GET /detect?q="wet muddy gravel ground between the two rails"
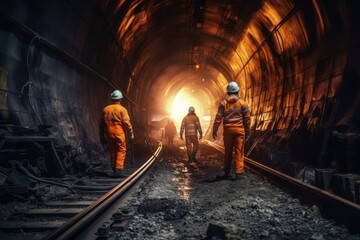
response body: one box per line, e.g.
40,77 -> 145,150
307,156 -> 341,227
113,145 -> 360,240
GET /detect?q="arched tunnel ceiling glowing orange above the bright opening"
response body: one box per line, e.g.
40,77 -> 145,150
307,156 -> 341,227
103,1 -> 260,115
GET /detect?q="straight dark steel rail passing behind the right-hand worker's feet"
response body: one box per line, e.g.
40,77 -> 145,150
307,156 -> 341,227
204,140 -> 360,233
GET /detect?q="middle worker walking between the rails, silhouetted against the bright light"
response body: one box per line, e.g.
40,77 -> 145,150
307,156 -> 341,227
180,107 -> 202,162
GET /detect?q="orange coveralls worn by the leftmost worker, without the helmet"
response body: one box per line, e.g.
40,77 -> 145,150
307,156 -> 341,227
103,102 -> 133,170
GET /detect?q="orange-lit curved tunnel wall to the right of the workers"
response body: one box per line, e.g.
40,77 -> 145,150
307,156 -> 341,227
239,1 -> 360,175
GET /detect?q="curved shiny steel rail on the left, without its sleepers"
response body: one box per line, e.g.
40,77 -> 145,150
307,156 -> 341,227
44,141 -> 162,240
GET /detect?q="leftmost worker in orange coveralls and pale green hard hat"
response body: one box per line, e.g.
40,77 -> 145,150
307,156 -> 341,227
100,90 -> 134,177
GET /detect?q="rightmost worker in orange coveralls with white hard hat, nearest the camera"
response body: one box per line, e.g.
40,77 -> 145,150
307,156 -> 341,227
212,82 -> 250,179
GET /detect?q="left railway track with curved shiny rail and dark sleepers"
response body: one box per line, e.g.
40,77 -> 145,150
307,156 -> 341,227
0,142 -> 162,239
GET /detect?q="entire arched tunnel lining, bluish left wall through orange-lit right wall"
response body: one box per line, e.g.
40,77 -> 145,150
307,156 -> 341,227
0,0 -> 360,178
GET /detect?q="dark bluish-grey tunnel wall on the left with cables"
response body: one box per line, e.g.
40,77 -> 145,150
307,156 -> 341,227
0,0 -> 127,150
